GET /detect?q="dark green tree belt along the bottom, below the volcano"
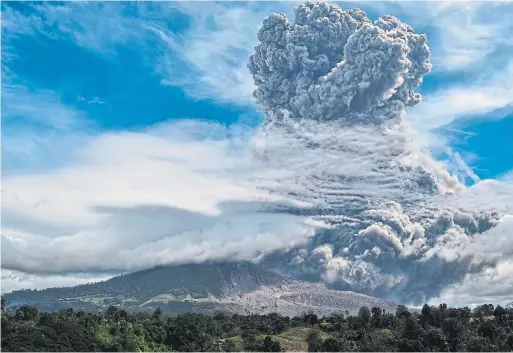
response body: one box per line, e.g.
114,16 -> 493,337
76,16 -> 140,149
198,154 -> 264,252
2,300 -> 513,352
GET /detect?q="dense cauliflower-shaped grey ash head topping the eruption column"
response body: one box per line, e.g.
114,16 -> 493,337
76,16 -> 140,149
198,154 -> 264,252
249,2 -> 431,120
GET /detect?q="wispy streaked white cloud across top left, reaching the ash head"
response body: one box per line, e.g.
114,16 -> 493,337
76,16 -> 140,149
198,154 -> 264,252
2,2 -> 286,104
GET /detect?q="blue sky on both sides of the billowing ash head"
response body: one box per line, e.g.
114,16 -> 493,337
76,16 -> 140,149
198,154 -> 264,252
2,3 -> 513,178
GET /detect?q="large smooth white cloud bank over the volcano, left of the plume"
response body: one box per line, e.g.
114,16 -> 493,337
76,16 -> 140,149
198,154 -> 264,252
2,121 -> 318,280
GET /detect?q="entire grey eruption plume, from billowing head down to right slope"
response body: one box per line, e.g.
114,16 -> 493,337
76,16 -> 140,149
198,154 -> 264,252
248,2 -> 513,304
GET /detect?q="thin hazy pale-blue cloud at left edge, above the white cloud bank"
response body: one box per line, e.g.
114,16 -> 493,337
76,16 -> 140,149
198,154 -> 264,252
2,84 -> 94,177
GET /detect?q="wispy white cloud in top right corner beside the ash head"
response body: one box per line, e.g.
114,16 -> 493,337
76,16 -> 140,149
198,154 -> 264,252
370,0 -> 513,73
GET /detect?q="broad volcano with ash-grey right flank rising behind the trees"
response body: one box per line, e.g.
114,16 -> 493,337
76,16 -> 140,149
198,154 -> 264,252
4,262 -> 397,316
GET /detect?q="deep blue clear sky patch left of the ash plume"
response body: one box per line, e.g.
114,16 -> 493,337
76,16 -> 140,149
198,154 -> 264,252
4,3 -> 256,131
